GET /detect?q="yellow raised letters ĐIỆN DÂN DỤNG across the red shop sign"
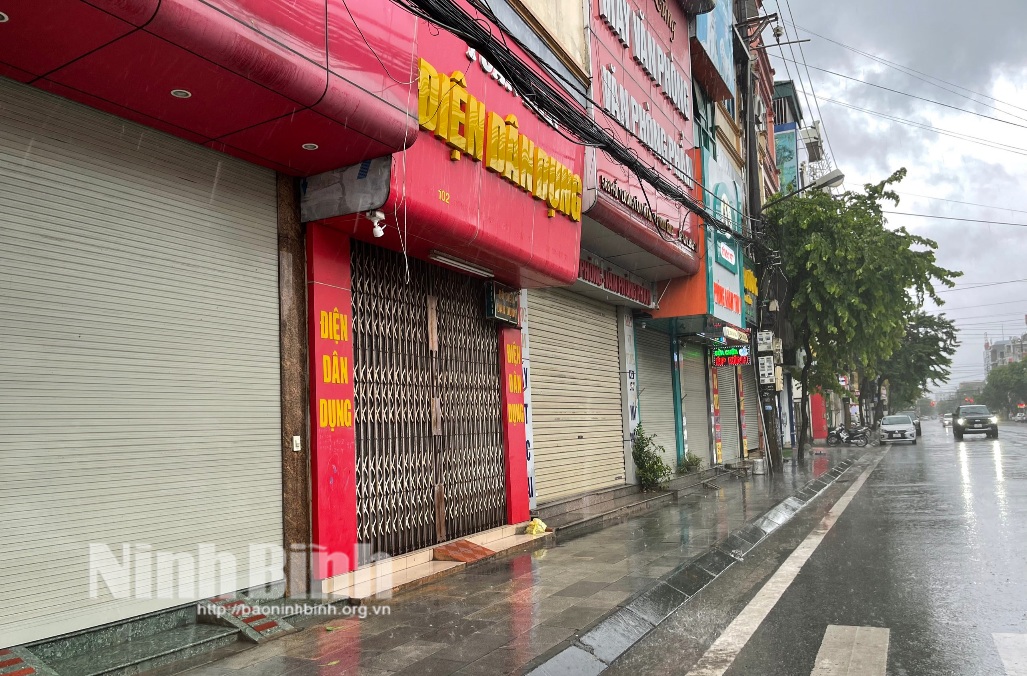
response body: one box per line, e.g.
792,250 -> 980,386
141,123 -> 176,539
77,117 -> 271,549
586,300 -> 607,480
418,59 -> 581,221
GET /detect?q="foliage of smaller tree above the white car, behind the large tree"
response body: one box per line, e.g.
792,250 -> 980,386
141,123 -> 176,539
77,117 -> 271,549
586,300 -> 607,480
877,310 -> 959,413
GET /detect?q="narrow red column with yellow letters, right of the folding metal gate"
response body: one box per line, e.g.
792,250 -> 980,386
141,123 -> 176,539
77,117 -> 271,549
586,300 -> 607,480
499,328 -> 530,524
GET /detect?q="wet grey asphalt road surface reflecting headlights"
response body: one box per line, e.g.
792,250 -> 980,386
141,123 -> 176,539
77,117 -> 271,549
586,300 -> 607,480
611,420 -> 1027,676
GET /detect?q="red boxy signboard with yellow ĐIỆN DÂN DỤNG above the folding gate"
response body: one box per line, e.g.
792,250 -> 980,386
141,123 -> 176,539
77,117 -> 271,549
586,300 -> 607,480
302,7 -> 585,286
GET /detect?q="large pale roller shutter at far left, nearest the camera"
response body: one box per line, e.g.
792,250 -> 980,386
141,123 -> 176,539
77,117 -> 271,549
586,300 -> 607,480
0,78 -> 282,645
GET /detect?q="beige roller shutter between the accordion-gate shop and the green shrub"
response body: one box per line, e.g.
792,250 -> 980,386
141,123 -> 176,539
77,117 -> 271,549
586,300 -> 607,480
528,289 -> 624,501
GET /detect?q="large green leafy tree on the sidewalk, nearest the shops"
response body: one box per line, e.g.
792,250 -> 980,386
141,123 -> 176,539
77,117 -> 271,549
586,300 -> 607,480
766,170 -> 961,458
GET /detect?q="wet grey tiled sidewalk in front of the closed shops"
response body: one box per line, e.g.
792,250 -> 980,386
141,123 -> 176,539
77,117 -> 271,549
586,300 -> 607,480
170,451 -> 844,676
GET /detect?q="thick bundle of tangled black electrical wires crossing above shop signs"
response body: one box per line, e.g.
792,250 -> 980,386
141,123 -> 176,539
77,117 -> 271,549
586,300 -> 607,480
392,0 -> 759,246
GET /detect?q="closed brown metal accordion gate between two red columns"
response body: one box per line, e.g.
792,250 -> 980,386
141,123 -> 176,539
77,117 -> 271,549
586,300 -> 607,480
351,239 -> 506,565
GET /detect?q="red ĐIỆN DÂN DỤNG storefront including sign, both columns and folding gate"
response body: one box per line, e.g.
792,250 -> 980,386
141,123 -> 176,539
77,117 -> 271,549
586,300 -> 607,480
303,2 -> 584,579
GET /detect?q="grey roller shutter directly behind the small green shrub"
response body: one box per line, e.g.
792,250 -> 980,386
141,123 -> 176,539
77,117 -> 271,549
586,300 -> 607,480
635,328 -> 678,467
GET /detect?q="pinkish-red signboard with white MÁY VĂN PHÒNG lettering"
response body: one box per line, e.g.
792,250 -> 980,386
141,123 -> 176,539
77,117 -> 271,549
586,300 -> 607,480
586,0 -> 699,262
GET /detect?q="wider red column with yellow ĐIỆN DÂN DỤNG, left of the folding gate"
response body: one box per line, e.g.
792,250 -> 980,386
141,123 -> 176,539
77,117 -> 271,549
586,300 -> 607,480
307,224 -> 356,579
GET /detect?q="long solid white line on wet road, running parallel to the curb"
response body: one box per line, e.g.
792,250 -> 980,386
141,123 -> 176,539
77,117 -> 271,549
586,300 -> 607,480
688,448 -> 888,676
